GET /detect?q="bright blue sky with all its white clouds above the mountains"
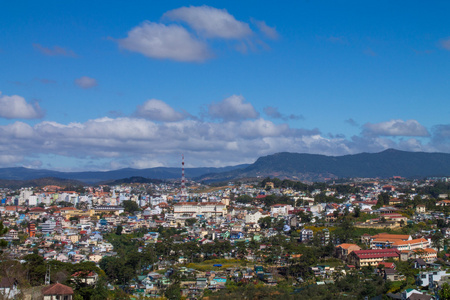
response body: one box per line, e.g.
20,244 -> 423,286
0,1 -> 450,170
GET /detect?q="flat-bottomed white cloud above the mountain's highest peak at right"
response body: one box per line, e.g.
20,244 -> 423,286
363,120 -> 429,136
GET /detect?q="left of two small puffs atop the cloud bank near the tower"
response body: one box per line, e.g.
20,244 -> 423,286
135,99 -> 185,122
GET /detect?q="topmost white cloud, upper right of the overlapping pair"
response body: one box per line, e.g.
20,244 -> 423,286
164,5 -> 252,39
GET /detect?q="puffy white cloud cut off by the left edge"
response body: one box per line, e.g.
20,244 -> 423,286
0,92 -> 44,119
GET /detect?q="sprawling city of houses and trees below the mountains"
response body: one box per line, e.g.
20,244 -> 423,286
0,178 -> 450,299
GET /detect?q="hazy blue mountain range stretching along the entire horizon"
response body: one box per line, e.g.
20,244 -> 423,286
0,149 -> 450,184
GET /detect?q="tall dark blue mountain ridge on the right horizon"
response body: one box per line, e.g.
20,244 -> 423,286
199,149 -> 450,181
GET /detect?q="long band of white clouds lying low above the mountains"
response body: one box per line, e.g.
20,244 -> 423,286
0,95 -> 450,170
